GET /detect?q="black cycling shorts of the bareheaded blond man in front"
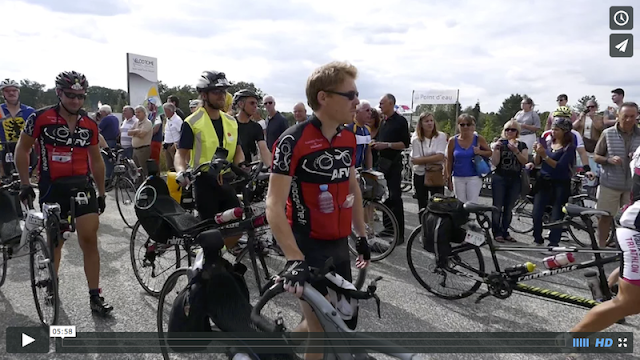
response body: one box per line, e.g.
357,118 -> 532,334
294,234 -> 353,296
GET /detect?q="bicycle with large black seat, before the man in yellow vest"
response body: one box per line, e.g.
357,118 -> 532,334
129,157 -> 285,296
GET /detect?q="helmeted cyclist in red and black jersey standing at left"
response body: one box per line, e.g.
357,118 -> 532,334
15,71 -> 113,315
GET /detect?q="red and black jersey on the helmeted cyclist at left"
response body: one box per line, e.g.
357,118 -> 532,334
23,105 -> 98,185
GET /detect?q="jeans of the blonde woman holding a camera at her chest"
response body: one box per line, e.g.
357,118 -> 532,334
491,174 -> 521,238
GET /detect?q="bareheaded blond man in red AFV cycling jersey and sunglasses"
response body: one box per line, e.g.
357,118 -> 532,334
267,62 -> 371,359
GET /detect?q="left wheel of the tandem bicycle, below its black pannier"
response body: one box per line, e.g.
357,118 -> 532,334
407,226 -> 484,300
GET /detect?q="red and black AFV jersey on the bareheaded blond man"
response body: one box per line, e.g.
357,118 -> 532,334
271,116 -> 356,240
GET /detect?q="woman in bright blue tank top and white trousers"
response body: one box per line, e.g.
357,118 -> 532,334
446,114 -> 492,203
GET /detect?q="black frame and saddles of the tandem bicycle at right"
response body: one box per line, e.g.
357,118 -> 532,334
448,213 -> 621,309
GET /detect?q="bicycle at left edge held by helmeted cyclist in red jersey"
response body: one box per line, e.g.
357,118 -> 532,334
0,176 -> 87,327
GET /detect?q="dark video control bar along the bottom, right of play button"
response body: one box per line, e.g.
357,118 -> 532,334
56,332 -> 633,354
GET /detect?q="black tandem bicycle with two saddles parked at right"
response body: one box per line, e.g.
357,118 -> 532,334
407,203 -> 620,309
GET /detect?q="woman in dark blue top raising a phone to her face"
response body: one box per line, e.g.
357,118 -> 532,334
533,118 -> 576,246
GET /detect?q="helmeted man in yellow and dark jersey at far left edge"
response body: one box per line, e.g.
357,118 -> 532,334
0,79 -> 37,178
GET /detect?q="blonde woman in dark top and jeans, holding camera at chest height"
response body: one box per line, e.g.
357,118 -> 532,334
491,120 -> 529,242
